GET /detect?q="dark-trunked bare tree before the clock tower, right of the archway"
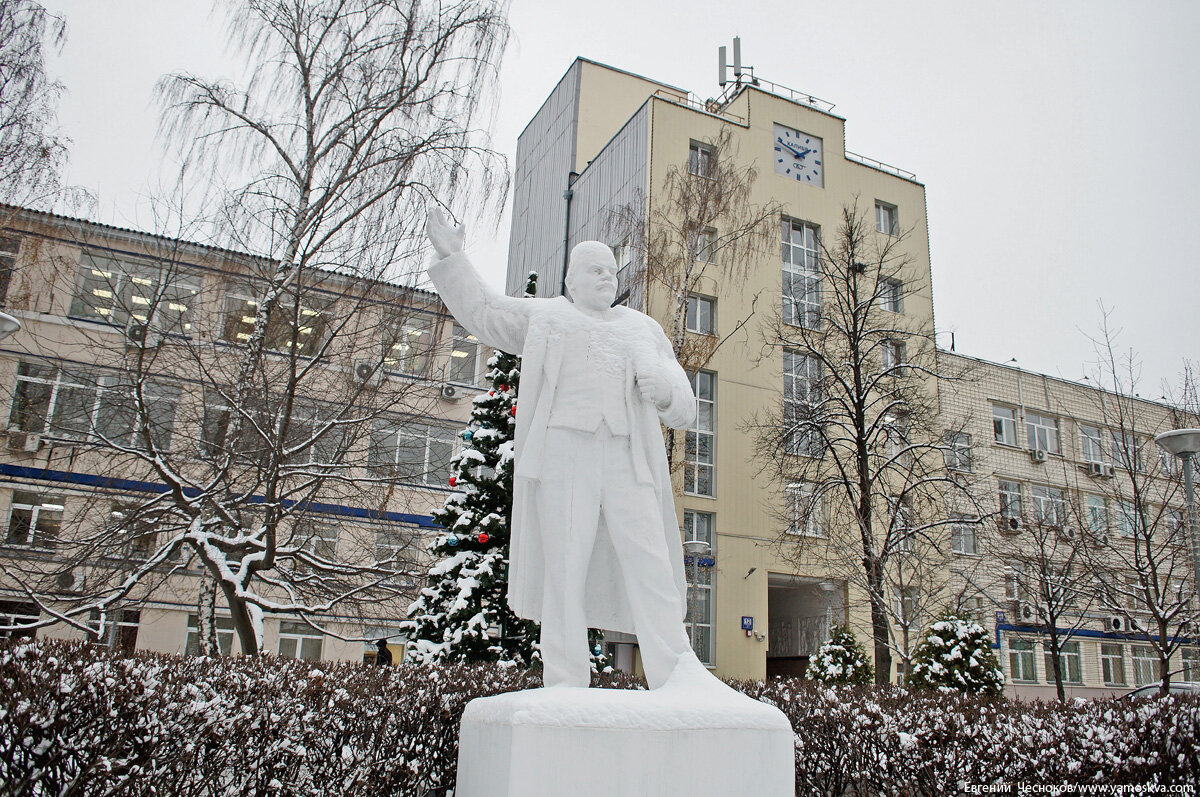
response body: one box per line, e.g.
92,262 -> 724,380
748,204 -> 972,683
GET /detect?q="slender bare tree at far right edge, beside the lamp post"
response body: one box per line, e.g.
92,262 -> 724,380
1086,311 -> 1200,695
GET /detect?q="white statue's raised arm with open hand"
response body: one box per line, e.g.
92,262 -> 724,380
425,210 -> 532,353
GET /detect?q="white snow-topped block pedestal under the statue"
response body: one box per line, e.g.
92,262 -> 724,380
455,678 -> 796,797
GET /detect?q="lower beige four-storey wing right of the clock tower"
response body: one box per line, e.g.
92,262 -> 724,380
940,352 -> 1200,697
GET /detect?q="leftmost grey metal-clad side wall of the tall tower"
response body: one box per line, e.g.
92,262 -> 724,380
505,61 -> 581,296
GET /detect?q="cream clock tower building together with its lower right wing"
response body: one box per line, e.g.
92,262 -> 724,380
508,59 -> 1196,695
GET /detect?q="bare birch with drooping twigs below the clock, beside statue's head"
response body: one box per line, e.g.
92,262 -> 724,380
610,127 -> 782,467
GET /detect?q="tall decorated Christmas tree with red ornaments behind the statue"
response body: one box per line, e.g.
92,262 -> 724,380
401,274 -> 539,666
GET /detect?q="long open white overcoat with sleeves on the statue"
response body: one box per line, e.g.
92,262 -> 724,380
428,246 -> 696,634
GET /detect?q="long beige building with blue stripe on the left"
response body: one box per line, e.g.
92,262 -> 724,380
0,206 -> 486,659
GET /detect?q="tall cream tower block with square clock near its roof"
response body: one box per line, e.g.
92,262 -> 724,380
508,59 -> 932,678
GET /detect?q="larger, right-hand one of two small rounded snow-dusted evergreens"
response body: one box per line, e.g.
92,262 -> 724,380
908,612 -> 1004,695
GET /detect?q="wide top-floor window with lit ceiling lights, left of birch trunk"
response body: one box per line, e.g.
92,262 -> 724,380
68,252 -> 200,334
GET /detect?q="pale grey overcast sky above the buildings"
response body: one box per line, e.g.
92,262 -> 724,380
46,0 -> 1200,397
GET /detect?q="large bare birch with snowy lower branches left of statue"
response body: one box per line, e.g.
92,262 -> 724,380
0,0 -> 506,653
